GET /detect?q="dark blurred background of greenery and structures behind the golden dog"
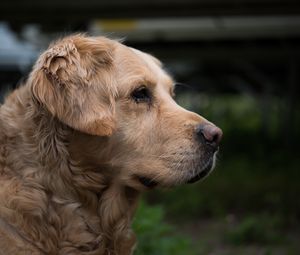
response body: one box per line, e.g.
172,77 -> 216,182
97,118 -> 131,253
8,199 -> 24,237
0,0 -> 300,255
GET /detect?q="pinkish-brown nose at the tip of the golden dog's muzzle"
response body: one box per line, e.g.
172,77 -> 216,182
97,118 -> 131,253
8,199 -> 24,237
196,124 -> 223,149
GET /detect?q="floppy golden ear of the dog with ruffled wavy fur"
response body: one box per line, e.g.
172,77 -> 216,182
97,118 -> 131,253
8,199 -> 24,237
30,35 -> 116,136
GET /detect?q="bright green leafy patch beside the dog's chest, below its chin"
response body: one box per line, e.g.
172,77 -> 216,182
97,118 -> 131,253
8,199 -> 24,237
133,202 -> 195,255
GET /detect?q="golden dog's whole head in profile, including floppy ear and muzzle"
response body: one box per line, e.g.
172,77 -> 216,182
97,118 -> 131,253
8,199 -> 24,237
30,35 -> 222,189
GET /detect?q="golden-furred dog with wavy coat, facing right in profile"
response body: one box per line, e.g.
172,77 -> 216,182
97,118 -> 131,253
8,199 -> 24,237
0,34 -> 222,255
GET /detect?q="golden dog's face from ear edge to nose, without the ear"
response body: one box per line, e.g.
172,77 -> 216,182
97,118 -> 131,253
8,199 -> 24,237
111,45 -> 221,187
